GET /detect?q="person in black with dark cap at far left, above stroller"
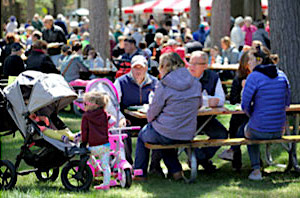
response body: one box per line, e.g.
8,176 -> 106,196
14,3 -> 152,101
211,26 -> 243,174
3,43 -> 25,78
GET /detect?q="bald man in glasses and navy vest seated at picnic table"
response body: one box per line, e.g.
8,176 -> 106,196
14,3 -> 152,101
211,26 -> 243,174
188,51 -> 228,172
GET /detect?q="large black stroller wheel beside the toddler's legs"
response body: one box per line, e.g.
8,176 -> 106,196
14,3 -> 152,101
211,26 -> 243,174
61,160 -> 93,191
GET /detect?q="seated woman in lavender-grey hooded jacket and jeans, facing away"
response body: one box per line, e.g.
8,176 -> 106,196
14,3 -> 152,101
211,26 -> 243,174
134,52 -> 201,180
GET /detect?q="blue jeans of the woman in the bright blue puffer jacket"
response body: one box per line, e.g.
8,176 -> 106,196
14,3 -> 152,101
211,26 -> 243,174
237,123 -> 282,169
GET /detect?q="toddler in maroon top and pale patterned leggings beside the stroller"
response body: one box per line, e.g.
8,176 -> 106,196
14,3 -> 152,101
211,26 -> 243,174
81,91 -> 110,190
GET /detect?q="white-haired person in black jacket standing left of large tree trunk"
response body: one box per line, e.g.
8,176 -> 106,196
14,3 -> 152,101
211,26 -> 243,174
42,15 -> 67,65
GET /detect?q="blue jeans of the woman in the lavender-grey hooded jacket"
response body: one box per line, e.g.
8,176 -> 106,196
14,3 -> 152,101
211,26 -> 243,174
134,123 -> 187,177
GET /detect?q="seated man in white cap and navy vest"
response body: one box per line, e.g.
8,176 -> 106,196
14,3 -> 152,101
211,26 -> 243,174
114,55 -> 158,164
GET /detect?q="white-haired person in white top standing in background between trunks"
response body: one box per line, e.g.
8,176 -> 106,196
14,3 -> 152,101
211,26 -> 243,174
230,16 -> 245,51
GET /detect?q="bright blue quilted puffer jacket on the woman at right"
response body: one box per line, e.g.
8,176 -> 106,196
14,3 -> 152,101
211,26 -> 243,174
242,65 -> 289,132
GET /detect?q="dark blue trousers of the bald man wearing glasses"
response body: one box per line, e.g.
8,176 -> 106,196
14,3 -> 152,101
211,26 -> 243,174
195,117 -> 228,161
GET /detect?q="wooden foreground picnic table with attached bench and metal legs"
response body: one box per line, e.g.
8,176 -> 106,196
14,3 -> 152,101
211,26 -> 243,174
125,104 -> 300,183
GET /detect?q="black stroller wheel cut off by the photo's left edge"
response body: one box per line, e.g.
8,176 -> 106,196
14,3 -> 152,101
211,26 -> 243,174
0,160 -> 17,190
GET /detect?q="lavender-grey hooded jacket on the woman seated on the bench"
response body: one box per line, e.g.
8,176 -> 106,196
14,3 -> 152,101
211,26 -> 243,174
147,68 -> 202,140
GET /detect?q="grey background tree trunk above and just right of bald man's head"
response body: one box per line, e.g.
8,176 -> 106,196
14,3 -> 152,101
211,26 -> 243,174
210,0 -> 230,47
